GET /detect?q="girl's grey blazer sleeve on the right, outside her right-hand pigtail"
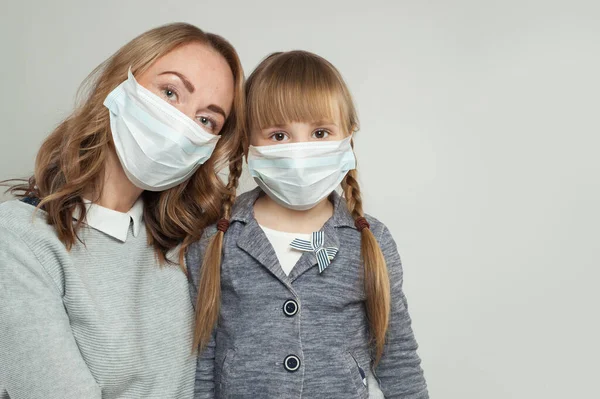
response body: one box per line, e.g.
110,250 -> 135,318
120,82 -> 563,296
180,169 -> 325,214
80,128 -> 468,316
375,227 -> 429,399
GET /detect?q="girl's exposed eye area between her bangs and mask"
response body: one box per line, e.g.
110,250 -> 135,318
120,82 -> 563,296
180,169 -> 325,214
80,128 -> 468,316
250,118 -> 347,147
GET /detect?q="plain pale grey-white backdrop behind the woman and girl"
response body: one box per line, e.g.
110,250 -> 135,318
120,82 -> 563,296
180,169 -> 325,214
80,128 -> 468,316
0,0 -> 600,399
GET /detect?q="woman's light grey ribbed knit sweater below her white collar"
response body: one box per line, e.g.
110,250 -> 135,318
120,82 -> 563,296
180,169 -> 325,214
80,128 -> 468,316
0,201 -> 196,399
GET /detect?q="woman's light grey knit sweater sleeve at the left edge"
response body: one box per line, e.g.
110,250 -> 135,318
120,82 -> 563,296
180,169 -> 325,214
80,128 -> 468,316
0,223 -> 101,399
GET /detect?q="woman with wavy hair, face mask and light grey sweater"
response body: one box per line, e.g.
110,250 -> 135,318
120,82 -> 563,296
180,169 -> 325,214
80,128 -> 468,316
0,24 -> 244,399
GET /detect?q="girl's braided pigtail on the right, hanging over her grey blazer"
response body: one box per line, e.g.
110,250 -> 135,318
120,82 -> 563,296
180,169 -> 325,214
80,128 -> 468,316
342,170 -> 391,364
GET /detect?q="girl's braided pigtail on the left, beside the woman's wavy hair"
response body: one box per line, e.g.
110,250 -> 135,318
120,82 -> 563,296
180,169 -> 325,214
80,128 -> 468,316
194,152 -> 243,351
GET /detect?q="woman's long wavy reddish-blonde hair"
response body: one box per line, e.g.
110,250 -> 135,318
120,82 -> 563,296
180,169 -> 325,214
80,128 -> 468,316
5,23 -> 246,265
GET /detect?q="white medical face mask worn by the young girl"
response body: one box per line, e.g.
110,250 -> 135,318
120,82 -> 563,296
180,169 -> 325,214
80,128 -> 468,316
248,136 -> 356,211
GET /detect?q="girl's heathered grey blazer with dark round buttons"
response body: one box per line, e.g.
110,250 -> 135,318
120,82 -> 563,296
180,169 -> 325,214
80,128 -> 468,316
186,188 -> 428,399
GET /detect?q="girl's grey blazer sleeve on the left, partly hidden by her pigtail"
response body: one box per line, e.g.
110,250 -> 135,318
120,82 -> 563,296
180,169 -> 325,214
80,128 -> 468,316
185,238 -> 216,399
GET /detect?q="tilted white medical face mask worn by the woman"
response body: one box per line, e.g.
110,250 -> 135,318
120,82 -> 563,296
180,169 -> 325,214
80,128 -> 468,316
104,70 -> 219,191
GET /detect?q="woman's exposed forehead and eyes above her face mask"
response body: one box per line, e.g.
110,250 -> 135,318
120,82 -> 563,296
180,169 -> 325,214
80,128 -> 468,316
135,43 -> 234,134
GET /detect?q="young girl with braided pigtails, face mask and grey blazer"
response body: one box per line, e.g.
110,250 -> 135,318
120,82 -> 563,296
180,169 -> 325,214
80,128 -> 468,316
186,51 -> 428,399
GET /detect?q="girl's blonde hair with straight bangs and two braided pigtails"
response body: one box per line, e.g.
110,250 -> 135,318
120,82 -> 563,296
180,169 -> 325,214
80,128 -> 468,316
194,51 -> 390,362
